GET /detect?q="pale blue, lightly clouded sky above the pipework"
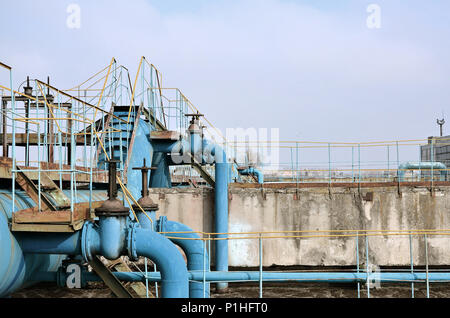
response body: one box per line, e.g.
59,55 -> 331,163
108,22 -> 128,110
0,0 -> 450,169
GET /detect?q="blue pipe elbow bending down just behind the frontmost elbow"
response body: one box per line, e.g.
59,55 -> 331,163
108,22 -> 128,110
158,216 -> 209,298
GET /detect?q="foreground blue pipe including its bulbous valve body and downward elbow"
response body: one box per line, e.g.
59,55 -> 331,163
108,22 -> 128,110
10,217 -> 189,298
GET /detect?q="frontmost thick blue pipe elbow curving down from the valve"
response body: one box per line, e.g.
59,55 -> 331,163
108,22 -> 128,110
130,227 -> 189,298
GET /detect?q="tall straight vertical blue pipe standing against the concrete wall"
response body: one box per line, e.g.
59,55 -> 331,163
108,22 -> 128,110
214,160 -> 228,291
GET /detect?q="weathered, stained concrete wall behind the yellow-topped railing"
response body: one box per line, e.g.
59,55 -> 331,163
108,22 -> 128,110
151,187 -> 450,266
